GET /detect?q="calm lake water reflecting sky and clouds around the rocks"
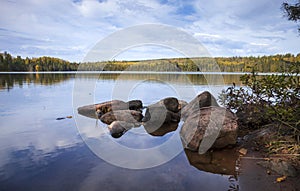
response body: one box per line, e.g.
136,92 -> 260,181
0,74 -> 239,190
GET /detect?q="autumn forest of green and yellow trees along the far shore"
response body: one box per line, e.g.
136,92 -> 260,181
0,52 -> 300,72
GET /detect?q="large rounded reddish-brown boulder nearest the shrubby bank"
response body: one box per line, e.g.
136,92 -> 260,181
180,106 -> 238,153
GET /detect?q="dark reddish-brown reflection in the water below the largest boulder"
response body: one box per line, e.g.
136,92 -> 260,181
184,149 -> 238,176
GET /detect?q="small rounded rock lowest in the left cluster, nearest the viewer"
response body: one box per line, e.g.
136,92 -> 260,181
108,121 -> 135,138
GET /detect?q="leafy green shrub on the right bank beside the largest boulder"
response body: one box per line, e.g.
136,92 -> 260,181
219,62 -> 300,135
